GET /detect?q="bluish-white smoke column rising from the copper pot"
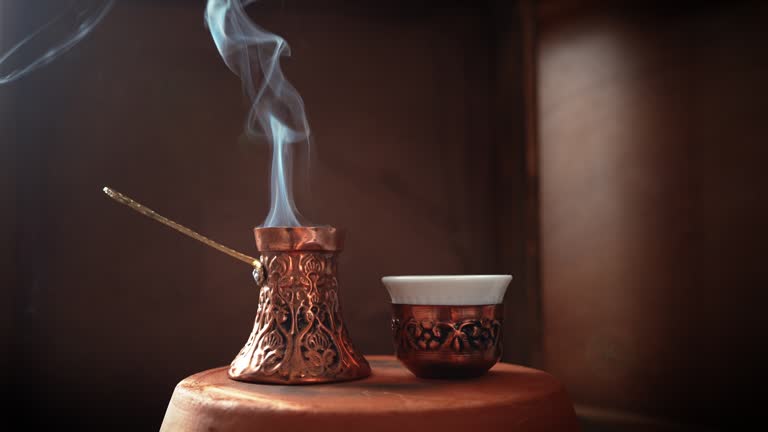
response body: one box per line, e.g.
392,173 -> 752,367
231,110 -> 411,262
205,0 -> 309,227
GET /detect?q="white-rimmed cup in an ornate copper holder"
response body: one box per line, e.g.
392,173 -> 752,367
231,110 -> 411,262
381,275 -> 512,378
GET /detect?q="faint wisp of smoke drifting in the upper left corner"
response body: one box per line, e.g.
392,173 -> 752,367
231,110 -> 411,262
0,0 -> 114,85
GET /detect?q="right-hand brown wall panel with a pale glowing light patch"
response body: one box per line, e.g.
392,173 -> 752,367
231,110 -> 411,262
537,2 -> 768,430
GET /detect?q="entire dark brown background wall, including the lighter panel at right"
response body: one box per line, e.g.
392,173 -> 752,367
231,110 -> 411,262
6,0 -> 768,430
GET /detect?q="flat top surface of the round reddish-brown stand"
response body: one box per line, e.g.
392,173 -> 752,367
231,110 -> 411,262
176,356 -> 564,414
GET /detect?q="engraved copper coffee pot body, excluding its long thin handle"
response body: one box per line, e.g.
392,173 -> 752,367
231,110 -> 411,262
229,226 -> 371,384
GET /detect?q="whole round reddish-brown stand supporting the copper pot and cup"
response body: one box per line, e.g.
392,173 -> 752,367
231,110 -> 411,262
160,356 -> 579,432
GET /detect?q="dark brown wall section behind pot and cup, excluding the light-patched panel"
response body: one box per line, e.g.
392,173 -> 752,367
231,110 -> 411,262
0,0 -> 528,430
